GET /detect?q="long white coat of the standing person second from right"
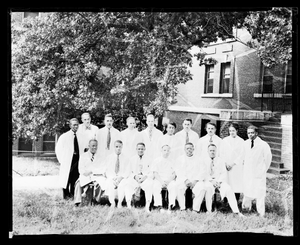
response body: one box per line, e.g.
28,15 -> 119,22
220,136 -> 244,193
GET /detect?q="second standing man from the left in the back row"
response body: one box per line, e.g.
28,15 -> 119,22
77,112 -> 99,154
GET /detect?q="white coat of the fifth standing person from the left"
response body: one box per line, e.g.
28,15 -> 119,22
140,127 -> 163,159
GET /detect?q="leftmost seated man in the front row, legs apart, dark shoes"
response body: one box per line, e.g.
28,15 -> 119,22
74,139 -> 105,205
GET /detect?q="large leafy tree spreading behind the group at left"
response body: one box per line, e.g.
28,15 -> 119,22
12,12 -> 246,139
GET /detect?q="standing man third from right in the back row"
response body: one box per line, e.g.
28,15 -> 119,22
197,122 -> 222,157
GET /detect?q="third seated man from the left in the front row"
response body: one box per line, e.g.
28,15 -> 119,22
125,142 -> 153,212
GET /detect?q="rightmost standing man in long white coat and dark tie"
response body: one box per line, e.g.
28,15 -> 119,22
242,126 -> 272,216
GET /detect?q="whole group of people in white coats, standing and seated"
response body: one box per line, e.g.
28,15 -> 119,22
55,113 -> 272,216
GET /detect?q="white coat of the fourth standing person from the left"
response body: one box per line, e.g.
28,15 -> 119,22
121,128 -> 141,158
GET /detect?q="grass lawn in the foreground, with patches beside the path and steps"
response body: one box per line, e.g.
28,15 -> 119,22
12,159 -> 293,236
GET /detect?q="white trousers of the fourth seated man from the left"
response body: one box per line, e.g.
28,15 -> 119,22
152,179 -> 176,207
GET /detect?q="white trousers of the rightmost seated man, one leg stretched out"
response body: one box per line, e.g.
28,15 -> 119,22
206,181 -> 240,213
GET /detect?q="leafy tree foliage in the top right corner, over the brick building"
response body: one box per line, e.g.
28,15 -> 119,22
244,8 -> 292,67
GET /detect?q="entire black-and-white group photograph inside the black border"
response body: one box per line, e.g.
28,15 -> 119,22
7,7 -> 299,236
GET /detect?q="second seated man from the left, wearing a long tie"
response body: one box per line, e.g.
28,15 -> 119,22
105,140 -> 131,208
